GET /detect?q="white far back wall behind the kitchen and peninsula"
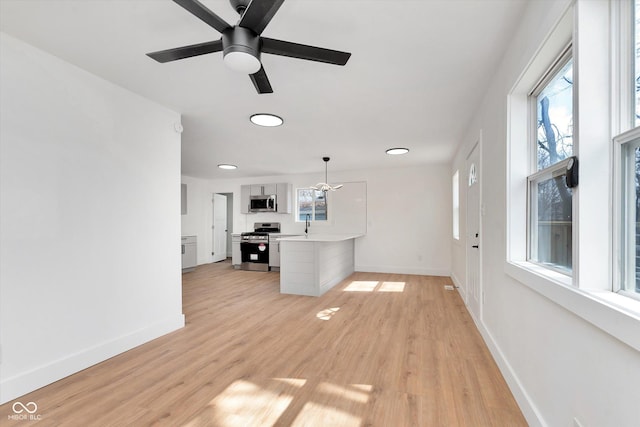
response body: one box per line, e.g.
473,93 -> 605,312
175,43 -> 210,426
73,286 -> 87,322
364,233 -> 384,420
182,164 -> 451,276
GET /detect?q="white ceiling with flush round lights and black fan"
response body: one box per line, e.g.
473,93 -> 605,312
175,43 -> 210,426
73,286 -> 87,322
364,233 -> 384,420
0,0 -> 526,178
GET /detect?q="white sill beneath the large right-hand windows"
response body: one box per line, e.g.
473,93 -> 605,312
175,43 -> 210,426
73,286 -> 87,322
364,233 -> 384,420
505,261 -> 640,351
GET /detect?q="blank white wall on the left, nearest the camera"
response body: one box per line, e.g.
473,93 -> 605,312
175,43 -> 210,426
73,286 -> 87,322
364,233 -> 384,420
0,34 -> 184,402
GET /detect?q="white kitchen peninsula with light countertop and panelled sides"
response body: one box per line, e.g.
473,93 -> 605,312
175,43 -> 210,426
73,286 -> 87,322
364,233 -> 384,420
278,234 -> 363,296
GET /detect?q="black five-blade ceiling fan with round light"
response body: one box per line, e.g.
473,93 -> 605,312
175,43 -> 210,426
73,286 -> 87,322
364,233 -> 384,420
147,0 -> 351,93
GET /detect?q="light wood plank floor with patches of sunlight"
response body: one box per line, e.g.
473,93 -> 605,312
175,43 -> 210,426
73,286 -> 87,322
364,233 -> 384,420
0,262 -> 526,427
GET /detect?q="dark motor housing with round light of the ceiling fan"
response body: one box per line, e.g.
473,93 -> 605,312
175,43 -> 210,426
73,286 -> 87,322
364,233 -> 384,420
222,26 -> 262,74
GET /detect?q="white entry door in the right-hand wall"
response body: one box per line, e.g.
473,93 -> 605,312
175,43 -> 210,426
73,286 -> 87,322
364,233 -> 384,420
466,144 -> 482,321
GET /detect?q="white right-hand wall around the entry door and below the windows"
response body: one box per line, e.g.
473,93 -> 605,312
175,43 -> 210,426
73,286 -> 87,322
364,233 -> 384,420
450,1 -> 640,427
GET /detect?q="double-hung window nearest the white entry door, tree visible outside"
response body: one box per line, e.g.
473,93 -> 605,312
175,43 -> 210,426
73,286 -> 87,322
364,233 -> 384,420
528,48 -> 573,274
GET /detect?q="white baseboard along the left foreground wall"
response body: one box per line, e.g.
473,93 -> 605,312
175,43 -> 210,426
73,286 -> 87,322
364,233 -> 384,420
0,314 -> 185,404
